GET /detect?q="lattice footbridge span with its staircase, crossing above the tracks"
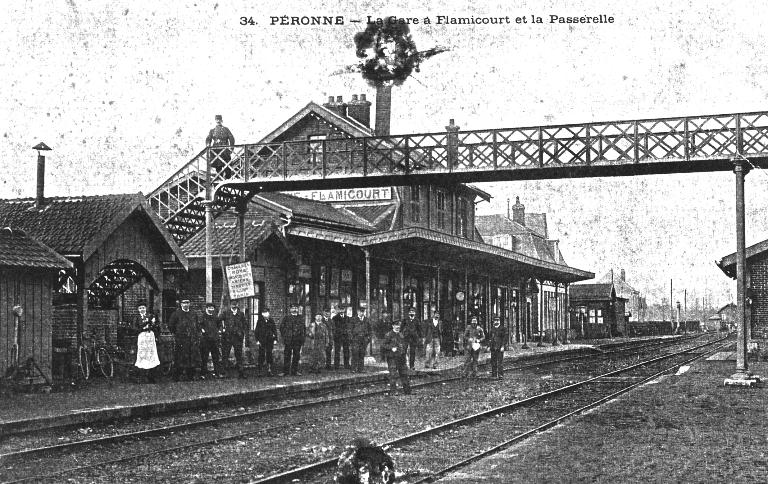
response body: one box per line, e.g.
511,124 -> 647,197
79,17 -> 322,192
148,112 -> 768,243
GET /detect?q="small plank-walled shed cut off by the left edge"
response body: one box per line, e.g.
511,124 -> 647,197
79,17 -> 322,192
0,227 -> 72,380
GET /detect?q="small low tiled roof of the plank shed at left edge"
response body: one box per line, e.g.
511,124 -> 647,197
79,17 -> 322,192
0,227 -> 72,269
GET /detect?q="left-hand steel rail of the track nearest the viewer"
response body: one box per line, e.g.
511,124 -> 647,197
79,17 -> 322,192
252,338 -> 726,484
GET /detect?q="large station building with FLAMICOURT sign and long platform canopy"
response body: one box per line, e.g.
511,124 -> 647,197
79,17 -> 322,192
164,96 -> 594,340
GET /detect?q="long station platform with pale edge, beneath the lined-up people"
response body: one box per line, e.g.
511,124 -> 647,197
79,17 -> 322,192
0,337 -> 672,436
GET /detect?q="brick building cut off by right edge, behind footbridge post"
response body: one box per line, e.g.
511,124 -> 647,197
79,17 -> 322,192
717,240 -> 768,339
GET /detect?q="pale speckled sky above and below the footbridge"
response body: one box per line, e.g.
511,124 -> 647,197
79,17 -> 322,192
0,0 -> 768,305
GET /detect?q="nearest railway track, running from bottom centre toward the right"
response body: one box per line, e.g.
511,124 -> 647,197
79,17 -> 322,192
249,338 -> 725,484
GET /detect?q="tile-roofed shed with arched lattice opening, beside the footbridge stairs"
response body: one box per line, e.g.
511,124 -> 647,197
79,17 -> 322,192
0,193 -> 187,378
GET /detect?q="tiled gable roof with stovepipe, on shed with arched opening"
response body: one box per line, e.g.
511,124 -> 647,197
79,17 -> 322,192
0,192 -> 186,265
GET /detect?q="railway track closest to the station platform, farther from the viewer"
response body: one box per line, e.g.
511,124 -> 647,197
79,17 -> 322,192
0,341 -> 708,482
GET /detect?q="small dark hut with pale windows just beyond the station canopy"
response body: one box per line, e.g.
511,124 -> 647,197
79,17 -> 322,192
570,283 -> 629,338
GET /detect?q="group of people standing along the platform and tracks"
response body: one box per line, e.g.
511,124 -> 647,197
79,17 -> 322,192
134,299 -> 508,393
